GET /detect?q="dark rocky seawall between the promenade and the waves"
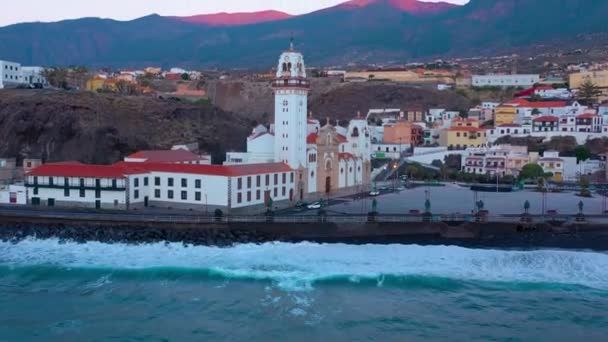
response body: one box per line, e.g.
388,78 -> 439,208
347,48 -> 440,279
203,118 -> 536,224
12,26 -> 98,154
0,210 -> 608,251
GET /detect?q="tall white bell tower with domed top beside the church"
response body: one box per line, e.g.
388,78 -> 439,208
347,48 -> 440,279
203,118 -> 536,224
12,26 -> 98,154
272,39 -> 310,169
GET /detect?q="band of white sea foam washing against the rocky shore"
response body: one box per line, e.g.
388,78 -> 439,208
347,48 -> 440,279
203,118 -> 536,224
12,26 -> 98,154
0,239 -> 608,289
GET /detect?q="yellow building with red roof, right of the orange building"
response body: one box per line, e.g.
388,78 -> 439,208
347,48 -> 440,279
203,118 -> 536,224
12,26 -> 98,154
439,119 -> 487,149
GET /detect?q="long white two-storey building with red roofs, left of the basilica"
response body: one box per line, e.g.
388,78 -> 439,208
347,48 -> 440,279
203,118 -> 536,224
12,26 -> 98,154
26,162 -> 295,211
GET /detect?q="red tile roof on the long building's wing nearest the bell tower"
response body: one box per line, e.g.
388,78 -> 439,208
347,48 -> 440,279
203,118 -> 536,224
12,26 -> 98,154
115,162 -> 293,177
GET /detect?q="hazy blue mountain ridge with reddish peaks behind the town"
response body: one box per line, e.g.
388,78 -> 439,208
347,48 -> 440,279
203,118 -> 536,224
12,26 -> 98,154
0,0 -> 608,69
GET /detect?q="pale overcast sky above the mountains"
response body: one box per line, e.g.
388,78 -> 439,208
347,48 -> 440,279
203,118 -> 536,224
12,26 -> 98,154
0,0 -> 468,26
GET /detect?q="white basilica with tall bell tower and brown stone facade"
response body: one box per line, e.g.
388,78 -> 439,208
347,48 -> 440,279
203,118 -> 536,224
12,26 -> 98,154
225,41 -> 372,201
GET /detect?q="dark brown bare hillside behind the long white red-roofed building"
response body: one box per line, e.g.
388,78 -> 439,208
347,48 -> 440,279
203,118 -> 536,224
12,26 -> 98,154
0,90 -> 251,163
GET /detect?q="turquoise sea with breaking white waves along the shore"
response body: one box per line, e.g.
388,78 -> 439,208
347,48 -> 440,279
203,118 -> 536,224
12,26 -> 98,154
0,240 -> 608,341
